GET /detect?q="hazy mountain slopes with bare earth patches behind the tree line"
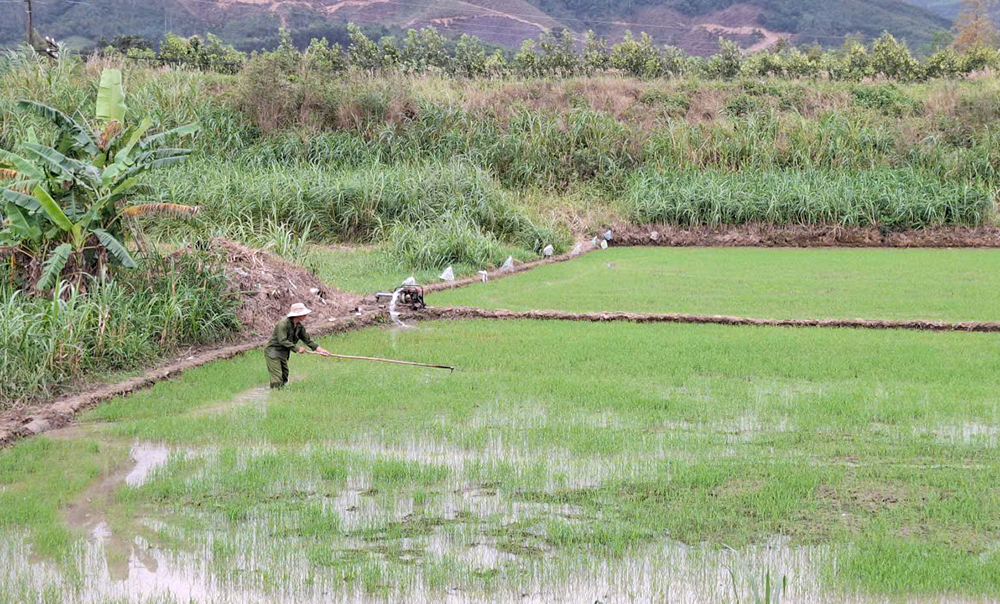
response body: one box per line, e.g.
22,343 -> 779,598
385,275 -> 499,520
0,0 -> 955,54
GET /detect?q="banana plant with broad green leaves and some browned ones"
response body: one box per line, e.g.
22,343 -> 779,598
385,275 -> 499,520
0,69 -> 198,290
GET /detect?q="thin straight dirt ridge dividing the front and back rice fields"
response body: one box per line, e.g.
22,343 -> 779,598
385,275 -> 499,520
414,306 -> 1000,332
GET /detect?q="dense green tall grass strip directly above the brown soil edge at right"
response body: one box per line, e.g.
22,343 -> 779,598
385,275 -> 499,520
620,169 -> 995,229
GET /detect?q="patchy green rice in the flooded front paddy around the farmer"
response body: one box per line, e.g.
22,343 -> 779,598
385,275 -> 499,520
0,322 -> 1000,601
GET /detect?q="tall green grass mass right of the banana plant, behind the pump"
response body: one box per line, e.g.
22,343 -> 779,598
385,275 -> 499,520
154,161 -> 568,269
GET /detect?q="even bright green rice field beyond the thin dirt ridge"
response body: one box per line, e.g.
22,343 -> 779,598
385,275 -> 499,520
436,248 -> 1000,321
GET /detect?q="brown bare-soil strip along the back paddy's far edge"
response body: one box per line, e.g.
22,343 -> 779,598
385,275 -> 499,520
610,224 -> 1000,248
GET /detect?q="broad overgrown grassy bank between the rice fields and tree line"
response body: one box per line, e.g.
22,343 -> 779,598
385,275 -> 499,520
0,54 -> 1000,241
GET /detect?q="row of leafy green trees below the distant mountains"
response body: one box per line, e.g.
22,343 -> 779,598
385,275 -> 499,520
100,23 -> 1000,82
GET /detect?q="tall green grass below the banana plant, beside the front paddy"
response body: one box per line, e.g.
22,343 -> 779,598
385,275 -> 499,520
0,250 -> 240,410
